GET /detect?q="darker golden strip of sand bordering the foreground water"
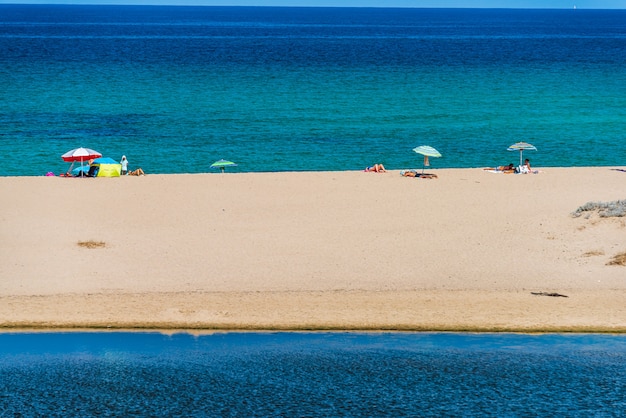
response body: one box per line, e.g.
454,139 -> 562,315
0,290 -> 626,334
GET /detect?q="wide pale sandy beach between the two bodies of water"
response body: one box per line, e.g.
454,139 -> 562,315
0,167 -> 626,332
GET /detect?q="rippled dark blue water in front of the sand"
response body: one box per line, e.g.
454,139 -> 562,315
0,333 -> 626,417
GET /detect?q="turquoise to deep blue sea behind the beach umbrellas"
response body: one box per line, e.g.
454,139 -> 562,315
0,5 -> 626,176
